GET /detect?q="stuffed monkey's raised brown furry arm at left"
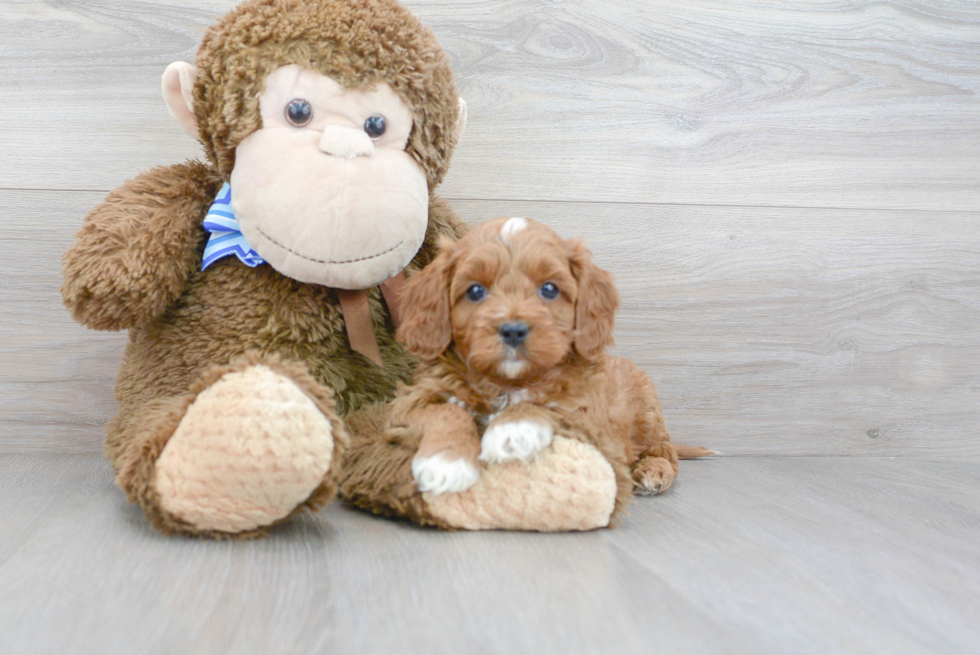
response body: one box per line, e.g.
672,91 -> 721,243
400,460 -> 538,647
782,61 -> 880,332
61,162 -> 221,330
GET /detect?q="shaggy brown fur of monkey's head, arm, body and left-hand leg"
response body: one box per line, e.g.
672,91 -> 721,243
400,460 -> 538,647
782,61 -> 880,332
62,0 -> 464,537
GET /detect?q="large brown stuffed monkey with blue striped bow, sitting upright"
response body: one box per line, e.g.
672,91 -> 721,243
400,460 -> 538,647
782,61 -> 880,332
62,0 -> 616,538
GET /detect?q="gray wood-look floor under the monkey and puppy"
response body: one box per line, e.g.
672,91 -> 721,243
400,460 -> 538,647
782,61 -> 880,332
0,455 -> 980,655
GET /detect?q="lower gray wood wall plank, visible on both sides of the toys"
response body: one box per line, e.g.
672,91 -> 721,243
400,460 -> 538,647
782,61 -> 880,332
0,191 -> 980,456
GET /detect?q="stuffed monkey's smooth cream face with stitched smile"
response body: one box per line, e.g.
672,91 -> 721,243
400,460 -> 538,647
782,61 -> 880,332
231,65 -> 429,289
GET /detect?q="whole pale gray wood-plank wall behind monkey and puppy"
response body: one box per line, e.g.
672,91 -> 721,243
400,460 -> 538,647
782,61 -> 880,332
0,0 -> 980,457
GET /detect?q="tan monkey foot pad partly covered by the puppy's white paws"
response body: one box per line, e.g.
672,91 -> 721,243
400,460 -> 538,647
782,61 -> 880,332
423,437 -> 616,532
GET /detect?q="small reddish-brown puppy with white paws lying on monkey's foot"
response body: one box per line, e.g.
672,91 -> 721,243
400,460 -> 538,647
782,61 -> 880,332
390,218 -> 711,494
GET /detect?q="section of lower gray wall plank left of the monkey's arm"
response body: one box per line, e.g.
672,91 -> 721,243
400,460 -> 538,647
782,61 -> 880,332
0,191 -> 126,452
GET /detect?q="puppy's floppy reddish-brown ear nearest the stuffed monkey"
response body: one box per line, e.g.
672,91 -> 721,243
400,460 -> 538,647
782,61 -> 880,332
398,239 -> 456,360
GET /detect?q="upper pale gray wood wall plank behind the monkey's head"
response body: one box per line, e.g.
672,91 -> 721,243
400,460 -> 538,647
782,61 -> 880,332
0,0 -> 980,211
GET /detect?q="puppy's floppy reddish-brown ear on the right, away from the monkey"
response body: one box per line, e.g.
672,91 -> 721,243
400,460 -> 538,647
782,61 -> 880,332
567,241 -> 619,359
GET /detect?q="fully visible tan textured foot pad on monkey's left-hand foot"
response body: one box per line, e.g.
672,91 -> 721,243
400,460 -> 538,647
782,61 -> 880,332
154,366 -> 333,533
